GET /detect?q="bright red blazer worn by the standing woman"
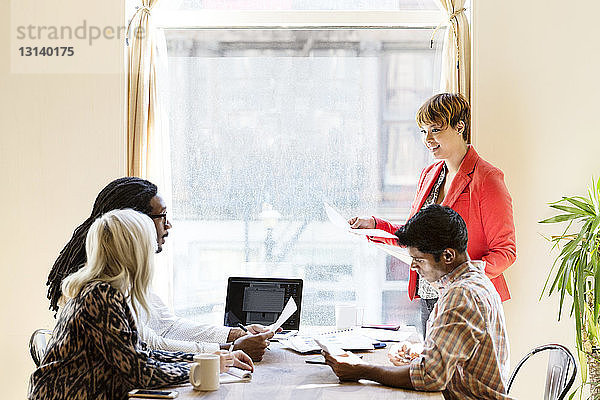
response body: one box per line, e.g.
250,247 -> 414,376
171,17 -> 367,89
374,146 -> 517,301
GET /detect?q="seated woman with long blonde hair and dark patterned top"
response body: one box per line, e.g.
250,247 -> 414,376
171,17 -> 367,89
29,209 -> 253,400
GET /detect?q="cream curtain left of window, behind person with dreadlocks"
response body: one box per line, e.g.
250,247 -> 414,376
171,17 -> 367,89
127,0 -> 173,304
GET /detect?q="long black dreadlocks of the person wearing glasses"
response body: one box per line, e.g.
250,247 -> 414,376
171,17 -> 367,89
46,177 -> 157,311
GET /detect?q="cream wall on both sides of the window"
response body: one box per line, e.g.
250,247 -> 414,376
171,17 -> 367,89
0,0 -> 600,399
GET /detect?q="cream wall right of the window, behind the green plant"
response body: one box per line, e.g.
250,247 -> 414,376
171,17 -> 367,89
473,0 -> 600,399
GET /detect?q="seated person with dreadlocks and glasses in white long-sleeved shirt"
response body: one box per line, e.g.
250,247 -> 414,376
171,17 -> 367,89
47,177 -> 272,361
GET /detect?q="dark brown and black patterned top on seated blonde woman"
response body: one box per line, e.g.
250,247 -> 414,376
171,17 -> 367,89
28,282 -> 194,400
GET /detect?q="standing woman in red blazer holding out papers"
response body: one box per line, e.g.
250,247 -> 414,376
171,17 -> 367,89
348,93 -> 517,333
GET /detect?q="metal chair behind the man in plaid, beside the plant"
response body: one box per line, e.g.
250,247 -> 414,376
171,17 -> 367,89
507,344 -> 577,400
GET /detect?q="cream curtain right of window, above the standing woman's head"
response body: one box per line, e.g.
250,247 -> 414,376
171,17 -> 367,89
437,0 -> 471,102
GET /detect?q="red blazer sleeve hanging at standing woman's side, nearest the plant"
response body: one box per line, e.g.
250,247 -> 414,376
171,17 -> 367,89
480,170 -> 517,278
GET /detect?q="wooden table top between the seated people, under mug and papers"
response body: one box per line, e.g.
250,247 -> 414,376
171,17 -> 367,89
162,343 -> 444,400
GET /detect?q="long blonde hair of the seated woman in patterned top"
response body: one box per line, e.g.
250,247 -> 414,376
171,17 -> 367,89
62,209 -> 157,318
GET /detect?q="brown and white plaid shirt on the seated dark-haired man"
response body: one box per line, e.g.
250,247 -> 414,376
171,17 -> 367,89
410,261 -> 510,400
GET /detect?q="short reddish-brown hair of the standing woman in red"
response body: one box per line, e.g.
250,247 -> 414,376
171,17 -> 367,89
416,93 -> 471,142
